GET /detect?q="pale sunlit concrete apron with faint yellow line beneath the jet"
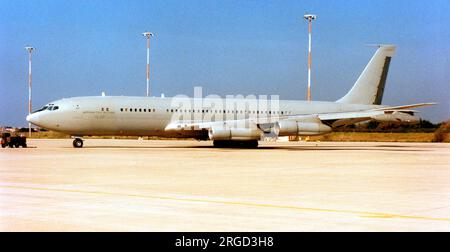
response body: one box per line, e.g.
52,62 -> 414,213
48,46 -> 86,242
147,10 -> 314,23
0,139 -> 450,231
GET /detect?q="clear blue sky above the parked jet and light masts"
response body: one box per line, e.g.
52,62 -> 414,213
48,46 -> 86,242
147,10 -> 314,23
0,0 -> 450,126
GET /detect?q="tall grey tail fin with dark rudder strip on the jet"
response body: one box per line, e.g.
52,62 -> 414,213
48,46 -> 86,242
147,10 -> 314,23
337,45 -> 395,105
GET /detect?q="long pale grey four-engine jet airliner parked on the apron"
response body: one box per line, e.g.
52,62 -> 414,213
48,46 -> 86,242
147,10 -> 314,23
27,45 -> 434,148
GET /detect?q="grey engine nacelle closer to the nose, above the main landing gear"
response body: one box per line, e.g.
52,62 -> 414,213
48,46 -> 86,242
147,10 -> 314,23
208,128 -> 262,141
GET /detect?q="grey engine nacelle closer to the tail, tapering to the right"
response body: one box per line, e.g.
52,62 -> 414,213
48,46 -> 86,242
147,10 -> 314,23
278,120 -> 331,136
